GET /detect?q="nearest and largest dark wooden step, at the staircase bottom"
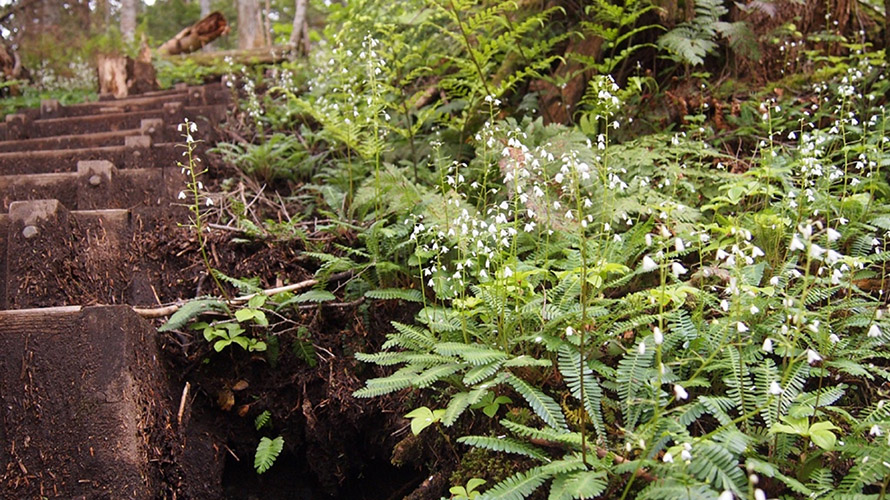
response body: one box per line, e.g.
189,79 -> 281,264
0,306 -> 178,499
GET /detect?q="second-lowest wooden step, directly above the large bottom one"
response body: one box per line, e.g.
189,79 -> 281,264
0,200 -> 186,309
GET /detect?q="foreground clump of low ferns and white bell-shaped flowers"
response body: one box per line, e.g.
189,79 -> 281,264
355,54 -> 890,499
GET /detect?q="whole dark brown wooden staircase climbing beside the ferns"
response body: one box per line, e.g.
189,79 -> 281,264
0,84 -> 230,498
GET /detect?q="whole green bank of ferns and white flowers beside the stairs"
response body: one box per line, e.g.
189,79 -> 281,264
173,0 -> 890,500
